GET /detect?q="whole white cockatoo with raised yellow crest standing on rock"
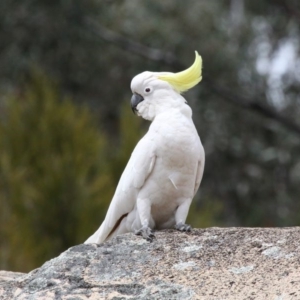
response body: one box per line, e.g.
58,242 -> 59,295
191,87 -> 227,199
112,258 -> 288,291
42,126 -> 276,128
85,52 -> 205,244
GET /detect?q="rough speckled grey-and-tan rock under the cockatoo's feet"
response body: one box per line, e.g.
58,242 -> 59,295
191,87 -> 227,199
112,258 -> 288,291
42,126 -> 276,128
0,227 -> 300,300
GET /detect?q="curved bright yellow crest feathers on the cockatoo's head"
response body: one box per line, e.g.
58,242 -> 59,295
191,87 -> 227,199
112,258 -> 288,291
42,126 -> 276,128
158,51 -> 202,93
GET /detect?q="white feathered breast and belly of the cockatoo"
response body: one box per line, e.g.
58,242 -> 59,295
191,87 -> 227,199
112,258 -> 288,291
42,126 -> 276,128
140,114 -> 202,202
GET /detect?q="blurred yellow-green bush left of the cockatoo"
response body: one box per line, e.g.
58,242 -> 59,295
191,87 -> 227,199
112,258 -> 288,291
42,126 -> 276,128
0,76 -> 113,270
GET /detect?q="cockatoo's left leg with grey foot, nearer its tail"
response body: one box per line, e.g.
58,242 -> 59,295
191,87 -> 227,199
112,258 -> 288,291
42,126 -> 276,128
135,198 -> 155,242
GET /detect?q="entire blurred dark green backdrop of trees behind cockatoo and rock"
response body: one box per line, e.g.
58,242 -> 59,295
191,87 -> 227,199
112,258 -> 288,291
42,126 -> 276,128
0,0 -> 300,271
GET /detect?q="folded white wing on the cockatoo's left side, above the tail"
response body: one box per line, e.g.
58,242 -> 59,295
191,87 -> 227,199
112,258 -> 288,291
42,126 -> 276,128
98,135 -> 155,243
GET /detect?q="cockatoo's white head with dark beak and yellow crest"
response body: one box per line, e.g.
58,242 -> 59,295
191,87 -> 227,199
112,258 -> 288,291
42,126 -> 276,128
131,51 -> 202,120
